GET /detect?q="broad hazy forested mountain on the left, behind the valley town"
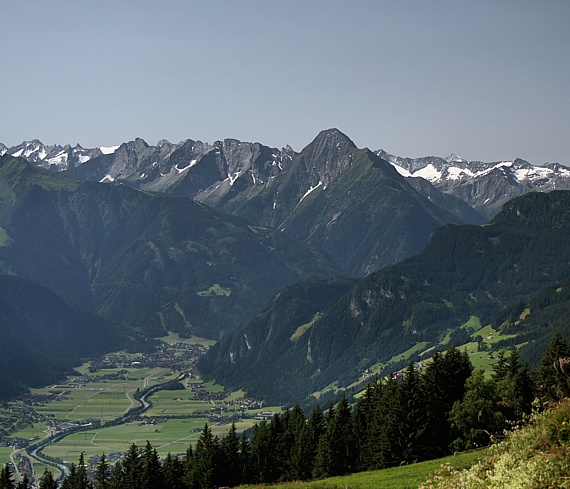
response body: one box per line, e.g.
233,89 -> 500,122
0,157 -> 339,337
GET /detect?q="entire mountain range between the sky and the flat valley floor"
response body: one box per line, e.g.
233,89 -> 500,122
0,129 -> 570,402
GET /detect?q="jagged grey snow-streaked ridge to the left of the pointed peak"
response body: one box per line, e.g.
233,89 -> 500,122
0,138 -> 295,197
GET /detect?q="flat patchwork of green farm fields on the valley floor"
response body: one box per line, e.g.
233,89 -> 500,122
0,335 -> 281,475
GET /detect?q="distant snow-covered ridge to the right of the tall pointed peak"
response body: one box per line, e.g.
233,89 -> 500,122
376,150 -> 570,218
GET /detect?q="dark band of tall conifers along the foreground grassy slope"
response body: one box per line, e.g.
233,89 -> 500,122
4,333 -> 570,489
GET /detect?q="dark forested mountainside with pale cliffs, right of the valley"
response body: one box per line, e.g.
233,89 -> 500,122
200,191 -> 570,402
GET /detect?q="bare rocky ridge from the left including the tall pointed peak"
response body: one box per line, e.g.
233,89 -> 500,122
2,129 -> 484,275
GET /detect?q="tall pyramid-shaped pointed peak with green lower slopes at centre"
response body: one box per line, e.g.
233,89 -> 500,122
198,129 -> 484,275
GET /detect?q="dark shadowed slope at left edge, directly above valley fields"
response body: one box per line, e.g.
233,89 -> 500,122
0,275 -> 121,399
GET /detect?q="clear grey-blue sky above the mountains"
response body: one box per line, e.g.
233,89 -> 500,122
0,0 -> 570,165
